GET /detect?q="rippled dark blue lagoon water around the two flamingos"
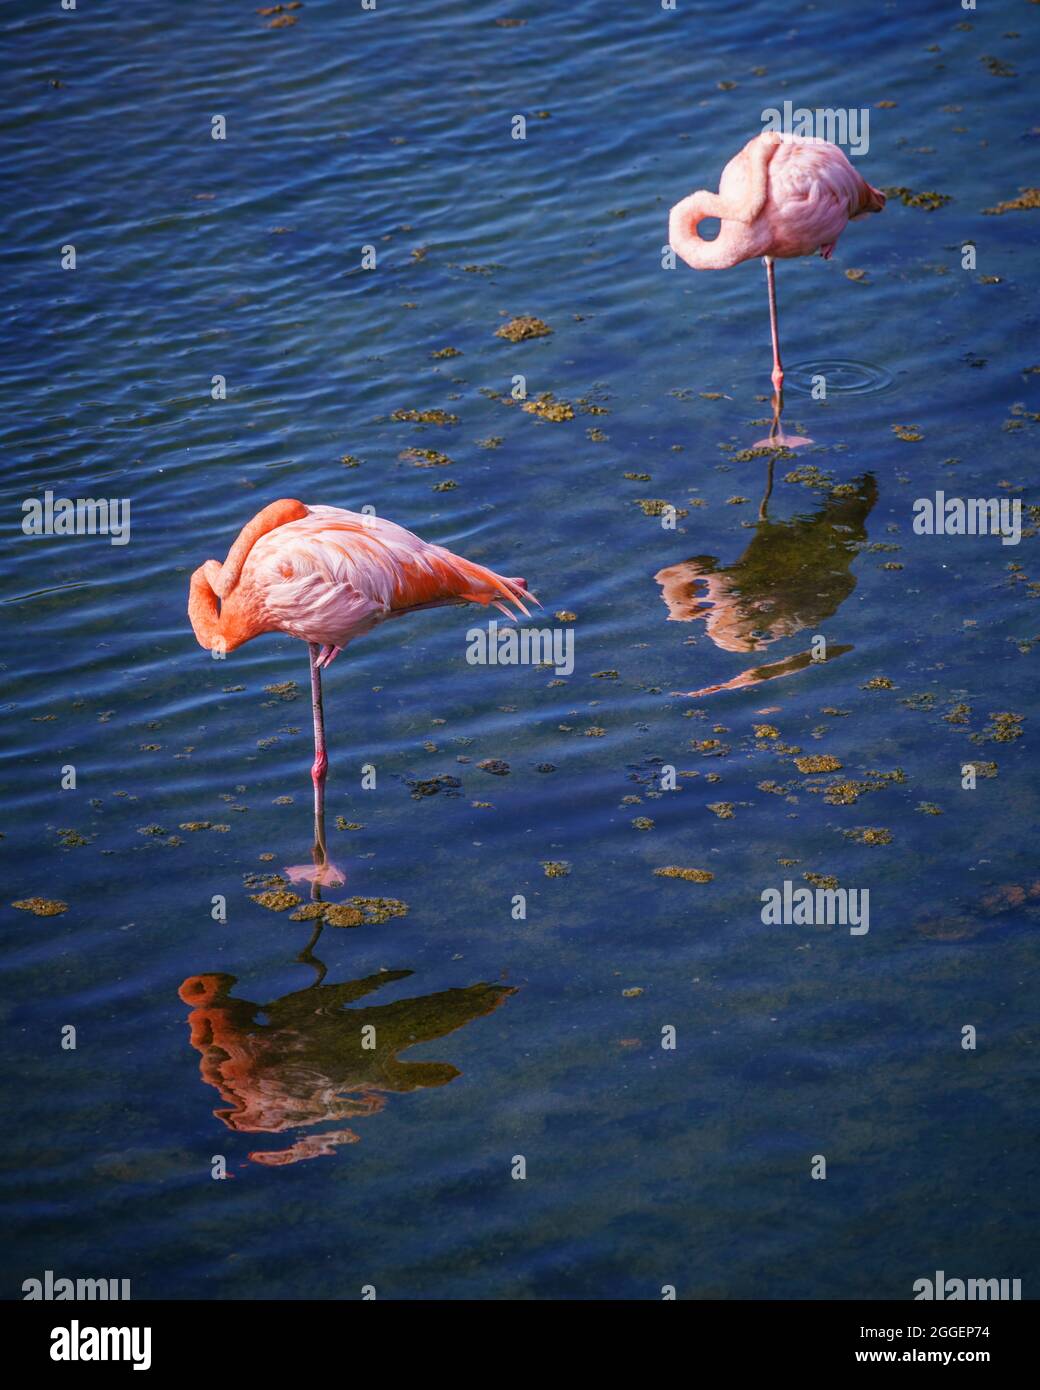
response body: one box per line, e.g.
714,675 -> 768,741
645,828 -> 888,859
0,3 -> 1040,1298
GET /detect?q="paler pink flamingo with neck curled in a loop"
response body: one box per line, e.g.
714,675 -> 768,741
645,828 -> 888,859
669,131 -> 884,391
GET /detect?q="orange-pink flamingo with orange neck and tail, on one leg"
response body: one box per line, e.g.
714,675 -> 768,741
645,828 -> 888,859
188,498 -> 537,865
